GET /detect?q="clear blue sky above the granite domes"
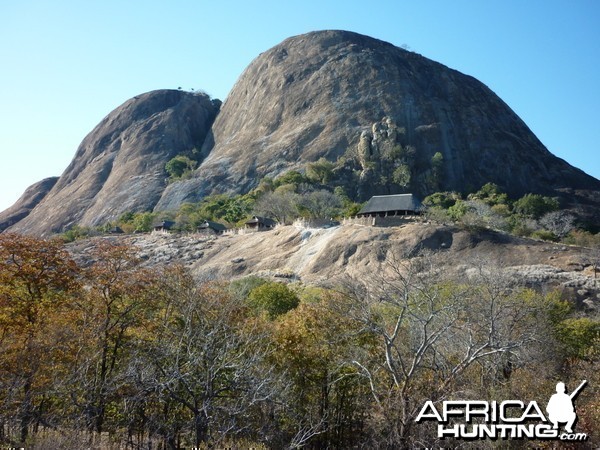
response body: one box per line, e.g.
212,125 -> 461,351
0,0 -> 600,210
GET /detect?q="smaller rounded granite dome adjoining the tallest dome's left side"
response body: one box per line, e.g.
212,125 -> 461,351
11,90 -> 219,235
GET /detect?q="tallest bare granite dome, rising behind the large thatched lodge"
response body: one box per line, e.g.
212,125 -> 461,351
158,31 -> 600,209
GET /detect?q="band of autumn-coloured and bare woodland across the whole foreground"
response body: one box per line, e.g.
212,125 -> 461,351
0,234 -> 600,449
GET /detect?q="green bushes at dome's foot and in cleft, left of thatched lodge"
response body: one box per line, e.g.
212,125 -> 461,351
61,167 -> 361,242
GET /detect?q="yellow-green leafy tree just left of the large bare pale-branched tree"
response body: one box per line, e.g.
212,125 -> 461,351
272,293 -> 370,448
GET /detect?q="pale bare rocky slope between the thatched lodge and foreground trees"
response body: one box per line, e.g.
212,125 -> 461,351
69,222 -> 600,309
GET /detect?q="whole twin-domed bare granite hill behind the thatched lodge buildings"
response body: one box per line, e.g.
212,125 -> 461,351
4,31 -> 600,234
